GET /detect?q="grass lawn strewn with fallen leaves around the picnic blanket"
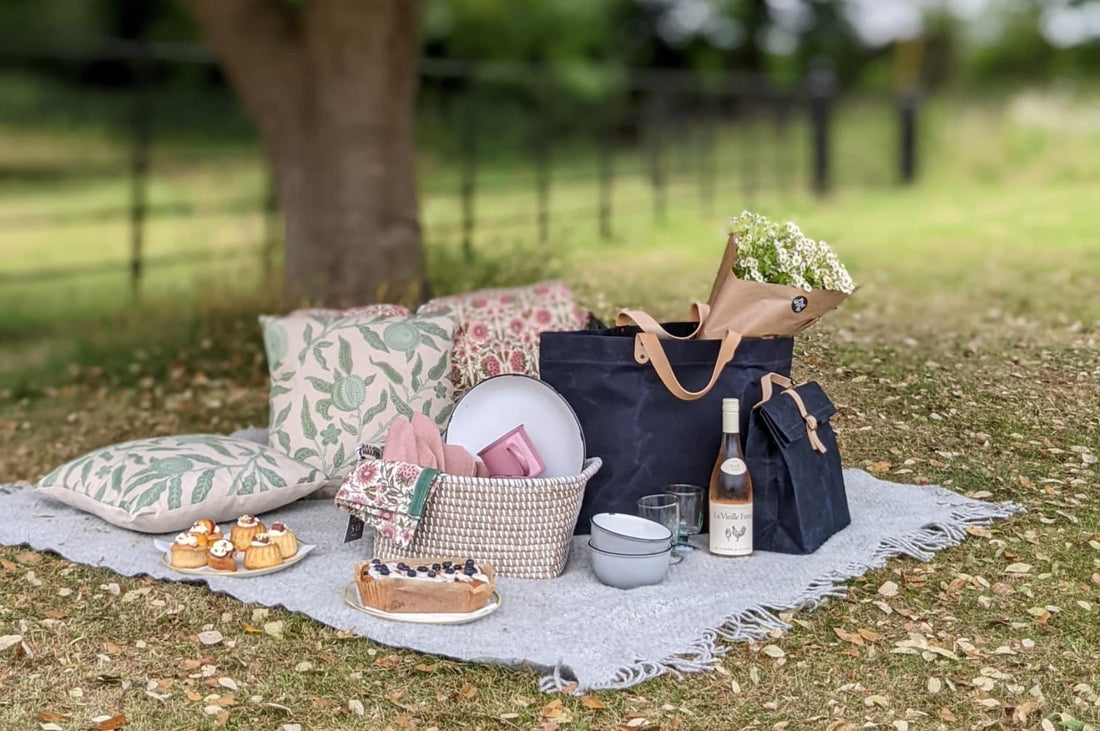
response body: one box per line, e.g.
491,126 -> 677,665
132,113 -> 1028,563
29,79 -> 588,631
0,88 -> 1100,731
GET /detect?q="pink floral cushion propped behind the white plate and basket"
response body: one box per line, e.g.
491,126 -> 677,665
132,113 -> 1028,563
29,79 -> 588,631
419,281 -> 589,396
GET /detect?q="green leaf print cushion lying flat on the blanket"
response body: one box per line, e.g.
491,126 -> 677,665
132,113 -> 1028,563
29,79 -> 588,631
35,434 -> 325,533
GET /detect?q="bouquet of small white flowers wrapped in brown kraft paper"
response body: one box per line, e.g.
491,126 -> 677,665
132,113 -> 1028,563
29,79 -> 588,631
699,211 -> 856,339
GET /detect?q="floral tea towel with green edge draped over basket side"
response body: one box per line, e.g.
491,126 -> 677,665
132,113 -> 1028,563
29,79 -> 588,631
334,459 -> 441,547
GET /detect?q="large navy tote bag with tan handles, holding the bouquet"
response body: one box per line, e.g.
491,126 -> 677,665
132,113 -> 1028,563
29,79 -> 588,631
539,312 -> 794,533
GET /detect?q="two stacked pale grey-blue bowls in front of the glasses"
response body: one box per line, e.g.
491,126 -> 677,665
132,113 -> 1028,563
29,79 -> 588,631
589,512 -> 672,589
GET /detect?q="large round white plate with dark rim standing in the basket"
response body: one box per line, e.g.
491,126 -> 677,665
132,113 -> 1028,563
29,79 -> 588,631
444,374 -> 584,477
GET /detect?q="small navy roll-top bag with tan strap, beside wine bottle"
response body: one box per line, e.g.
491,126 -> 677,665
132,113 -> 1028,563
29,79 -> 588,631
743,374 -> 851,554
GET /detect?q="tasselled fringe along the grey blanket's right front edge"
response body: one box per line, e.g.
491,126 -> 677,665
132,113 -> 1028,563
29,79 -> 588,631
539,502 -> 1023,695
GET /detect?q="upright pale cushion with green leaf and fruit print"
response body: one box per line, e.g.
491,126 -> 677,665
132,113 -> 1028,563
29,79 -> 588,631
260,304 -> 458,480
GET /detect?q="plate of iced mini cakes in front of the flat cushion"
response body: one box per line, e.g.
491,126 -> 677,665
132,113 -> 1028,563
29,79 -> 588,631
153,516 -> 316,577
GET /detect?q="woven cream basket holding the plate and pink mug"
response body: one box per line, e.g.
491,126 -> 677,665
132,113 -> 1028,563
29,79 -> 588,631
374,458 -> 602,578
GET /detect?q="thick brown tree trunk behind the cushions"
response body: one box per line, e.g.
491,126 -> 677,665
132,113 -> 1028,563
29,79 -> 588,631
185,0 -> 425,304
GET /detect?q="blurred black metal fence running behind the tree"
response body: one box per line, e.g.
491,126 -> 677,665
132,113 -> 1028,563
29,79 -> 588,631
0,41 -> 917,293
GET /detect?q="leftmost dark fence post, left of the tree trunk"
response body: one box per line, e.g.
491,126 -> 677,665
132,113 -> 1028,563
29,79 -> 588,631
130,43 -> 153,298
